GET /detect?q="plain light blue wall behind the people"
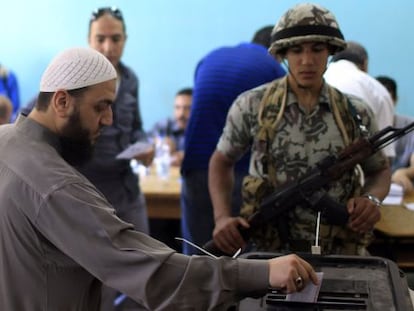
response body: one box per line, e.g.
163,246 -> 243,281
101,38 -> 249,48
0,0 -> 414,129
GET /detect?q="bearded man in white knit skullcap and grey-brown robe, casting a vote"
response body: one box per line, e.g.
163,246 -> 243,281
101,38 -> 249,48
0,48 -> 317,311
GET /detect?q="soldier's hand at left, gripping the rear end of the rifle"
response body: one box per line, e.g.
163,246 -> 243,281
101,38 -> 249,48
213,217 -> 250,255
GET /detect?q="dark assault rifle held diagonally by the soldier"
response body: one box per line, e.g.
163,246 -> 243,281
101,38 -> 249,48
204,122 -> 414,256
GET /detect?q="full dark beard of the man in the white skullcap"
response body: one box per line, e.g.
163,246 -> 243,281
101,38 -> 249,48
60,111 -> 93,166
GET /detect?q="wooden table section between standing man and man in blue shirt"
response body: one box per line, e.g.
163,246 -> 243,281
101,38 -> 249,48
140,167 -> 181,219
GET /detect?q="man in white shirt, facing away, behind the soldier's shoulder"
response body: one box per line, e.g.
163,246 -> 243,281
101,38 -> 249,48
324,41 -> 395,158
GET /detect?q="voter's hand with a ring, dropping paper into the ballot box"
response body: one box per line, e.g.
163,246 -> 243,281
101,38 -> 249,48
269,255 -> 318,293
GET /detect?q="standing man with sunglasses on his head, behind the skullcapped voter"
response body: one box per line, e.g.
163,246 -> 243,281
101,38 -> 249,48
21,7 -> 154,311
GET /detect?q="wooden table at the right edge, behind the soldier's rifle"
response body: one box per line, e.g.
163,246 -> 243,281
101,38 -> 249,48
374,193 -> 414,269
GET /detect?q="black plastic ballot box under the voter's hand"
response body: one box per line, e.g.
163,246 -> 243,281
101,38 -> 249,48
235,253 -> 414,311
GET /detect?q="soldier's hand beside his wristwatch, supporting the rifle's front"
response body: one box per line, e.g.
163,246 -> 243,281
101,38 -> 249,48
347,197 -> 381,233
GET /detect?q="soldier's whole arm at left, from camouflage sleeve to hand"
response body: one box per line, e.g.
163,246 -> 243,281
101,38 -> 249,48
208,92 -> 258,254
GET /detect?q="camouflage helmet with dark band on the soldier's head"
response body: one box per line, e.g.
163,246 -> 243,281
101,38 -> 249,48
269,3 -> 346,55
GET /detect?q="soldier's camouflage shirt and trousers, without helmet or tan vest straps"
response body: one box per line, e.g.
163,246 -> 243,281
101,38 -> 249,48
217,77 -> 385,254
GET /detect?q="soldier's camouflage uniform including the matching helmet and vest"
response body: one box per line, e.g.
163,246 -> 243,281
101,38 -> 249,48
217,3 -> 387,255
